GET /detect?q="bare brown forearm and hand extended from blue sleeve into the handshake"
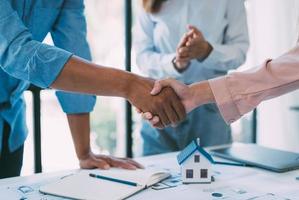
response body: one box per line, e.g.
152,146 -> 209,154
51,56 -> 186,126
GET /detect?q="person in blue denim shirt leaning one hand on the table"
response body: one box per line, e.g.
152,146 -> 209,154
0,0 -> 185,178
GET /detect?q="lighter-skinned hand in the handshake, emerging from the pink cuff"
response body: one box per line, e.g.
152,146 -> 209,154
137,78 -> 215,128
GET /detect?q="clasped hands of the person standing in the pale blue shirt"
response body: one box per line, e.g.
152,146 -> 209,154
178,25 -> 213,61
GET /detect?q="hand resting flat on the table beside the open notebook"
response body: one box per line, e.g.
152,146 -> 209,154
79,152 -> 144,170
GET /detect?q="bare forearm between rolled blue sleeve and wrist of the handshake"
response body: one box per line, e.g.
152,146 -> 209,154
51,56 -> 138,98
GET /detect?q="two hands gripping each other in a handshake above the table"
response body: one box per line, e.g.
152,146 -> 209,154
127,77 -> 215,129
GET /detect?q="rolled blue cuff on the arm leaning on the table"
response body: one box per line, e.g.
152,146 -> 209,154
56,91 -> 96,114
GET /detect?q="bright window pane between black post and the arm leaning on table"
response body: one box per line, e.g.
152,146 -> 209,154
41,90 -> 78,172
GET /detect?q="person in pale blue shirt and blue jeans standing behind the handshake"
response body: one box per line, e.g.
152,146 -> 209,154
134,0 -> 249,155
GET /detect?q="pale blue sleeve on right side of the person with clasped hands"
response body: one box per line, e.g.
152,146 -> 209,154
201,0 -> 249,72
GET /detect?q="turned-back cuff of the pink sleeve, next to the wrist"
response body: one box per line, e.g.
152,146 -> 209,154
209,76 -> 241,124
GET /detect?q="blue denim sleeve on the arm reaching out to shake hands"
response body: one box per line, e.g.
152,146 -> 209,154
0,0 -> 72,88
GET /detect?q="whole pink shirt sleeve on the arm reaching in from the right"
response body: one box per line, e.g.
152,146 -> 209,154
209,45 -> 299,123
